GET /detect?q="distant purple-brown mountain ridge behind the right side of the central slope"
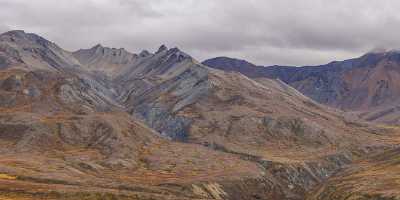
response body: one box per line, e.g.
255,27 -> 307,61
203,51 -> 400,124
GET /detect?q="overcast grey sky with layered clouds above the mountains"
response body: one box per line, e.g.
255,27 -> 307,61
0,0 -> 400,65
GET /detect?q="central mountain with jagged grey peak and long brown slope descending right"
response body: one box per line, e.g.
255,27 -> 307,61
96,44 -> 400,198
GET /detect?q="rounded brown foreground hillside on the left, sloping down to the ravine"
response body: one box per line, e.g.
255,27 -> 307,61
0,40 -> 261,199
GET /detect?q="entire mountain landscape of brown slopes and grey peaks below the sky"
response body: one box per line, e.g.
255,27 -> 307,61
0,31 -> 399,200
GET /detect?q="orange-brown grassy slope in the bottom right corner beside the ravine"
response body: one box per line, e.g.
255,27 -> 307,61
308,145 -> 400,200
